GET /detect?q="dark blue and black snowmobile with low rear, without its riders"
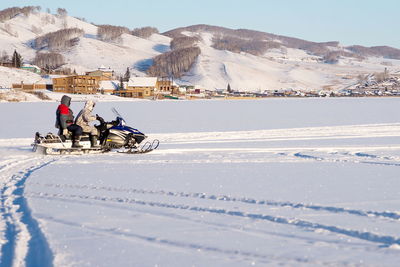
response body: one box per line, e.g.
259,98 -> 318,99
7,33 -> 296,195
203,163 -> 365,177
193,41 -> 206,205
32,108 -> 160,155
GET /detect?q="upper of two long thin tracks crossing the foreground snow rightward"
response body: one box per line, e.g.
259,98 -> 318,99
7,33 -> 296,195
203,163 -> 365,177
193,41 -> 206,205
28,183 -> 400,221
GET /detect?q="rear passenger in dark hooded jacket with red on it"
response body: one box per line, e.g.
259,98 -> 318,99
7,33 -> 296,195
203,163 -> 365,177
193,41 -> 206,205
55,95 -> 83,148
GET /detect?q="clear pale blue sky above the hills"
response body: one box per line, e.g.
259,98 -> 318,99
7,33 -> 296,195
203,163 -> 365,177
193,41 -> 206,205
0,0 -> 400,48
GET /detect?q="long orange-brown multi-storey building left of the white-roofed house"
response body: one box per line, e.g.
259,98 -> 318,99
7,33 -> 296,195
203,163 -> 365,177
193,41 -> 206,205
53,75 -> 100,94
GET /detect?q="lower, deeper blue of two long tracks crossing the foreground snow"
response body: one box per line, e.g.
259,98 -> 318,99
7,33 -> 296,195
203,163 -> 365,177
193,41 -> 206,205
29,192 -> 400,249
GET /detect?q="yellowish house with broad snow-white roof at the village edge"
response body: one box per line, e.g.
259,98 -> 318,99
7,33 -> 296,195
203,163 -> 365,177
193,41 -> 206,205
114,77 -> 157,98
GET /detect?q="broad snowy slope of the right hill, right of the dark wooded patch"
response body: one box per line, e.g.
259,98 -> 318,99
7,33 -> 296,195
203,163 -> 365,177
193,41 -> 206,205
166,25 -> 400,91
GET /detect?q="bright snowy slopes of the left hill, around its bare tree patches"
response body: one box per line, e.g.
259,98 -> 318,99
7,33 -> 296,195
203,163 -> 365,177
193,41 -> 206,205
0,8 -> 170,81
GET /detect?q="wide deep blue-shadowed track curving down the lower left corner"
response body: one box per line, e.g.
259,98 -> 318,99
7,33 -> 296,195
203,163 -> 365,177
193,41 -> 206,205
0,157 -> 55,267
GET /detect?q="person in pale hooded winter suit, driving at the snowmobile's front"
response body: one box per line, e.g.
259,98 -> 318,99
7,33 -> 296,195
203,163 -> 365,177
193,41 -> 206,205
75,100 -> 100,148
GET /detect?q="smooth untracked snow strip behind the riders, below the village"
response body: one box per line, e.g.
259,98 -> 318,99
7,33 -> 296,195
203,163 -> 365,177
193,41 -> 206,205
0,98 -> 400,138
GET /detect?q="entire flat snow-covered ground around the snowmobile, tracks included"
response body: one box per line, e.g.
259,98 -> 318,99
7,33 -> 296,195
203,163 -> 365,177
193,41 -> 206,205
0,98 -> 400,266
